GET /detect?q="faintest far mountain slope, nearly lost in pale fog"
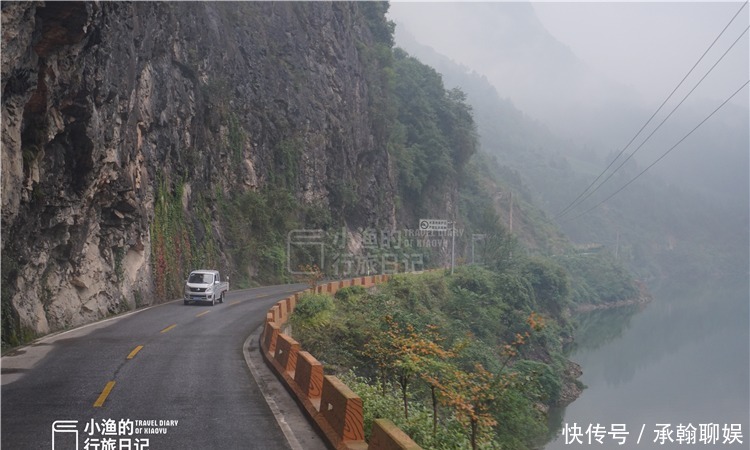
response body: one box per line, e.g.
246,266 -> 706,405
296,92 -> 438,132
391,2 -> 634,144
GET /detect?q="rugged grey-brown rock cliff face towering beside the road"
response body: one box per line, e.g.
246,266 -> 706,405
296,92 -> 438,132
2,2 -> 395,344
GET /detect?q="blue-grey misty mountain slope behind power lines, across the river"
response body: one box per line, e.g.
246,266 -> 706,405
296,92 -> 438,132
395,14 -> 748,277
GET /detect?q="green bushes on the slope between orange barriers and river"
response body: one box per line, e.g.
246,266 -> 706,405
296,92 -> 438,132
292,256 -> 636,449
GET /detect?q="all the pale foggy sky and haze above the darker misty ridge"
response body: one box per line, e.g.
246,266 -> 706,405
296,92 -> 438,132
389,2 -> 750,205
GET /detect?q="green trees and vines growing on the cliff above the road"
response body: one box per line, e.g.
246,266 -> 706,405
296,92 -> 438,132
144,3 -> 644,303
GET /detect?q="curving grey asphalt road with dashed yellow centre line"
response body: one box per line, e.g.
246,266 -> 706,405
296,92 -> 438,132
0,285 -> 322,450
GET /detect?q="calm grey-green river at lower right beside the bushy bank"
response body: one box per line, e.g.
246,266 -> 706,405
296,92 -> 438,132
545,277 -> 750,450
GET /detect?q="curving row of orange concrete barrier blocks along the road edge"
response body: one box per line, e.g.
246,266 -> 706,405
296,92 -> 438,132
260,276 -> 420,450
